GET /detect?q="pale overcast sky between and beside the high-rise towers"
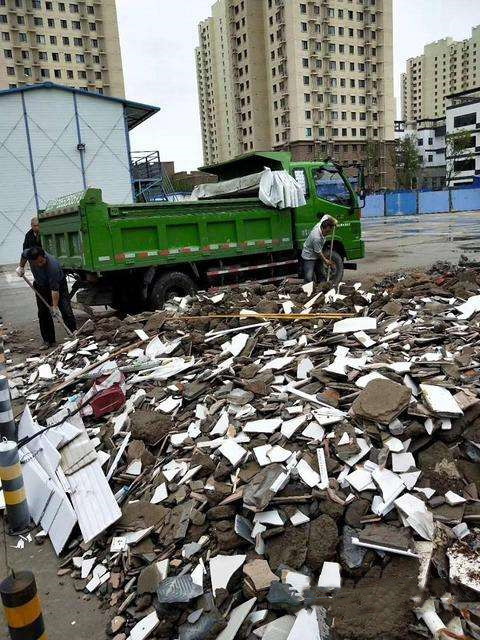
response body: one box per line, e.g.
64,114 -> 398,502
117,0 -> 480,171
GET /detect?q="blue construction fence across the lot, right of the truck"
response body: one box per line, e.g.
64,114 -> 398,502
362,189 -> 480,218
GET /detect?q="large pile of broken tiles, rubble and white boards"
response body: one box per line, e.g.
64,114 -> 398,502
2,265 -> 480,640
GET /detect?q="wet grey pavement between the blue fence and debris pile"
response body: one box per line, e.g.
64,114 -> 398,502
356,211 -> 480,276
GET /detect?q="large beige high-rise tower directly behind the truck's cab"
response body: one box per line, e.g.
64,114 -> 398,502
196,0 -> 394,181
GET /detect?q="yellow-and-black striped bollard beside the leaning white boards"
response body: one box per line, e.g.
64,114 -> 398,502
0,440 -> 30,534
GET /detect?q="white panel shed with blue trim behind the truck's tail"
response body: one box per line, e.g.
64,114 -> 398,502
0,83 -> 159,264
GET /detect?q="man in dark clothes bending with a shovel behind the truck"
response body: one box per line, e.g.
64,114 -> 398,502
17,247 -> 77,348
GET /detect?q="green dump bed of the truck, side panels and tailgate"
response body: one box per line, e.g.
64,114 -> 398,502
39,189 -> 293,272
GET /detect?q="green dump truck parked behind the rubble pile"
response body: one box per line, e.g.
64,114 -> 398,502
39,152 -> 364,309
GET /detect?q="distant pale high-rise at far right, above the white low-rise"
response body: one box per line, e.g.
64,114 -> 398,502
401,26 -> 480,122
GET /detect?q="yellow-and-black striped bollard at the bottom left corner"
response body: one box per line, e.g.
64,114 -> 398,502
0,571 -> 47,640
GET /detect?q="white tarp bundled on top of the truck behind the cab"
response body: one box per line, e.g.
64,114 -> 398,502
191,168 -> 306,209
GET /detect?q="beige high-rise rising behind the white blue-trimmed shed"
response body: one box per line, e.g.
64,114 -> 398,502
0,0 -> 125,98
